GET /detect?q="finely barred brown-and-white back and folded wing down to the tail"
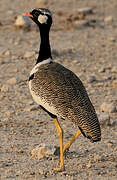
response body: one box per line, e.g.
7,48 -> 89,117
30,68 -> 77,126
31,62 -> 101,142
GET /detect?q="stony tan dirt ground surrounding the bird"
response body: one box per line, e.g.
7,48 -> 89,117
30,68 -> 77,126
0,0 -> 117,180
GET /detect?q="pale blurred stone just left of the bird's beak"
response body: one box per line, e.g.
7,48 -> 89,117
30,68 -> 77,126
14,15 -> 31,28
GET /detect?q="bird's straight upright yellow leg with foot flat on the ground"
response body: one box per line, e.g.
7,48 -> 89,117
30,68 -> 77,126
54,118 -> 64,171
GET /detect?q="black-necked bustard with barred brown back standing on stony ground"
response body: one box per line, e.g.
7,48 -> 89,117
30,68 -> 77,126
25,8 -> 101,171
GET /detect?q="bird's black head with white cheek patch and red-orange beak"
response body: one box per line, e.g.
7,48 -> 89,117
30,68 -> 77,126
25,8 -> 52,28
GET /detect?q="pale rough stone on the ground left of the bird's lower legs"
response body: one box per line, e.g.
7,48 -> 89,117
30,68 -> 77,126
31,144 -> 56,160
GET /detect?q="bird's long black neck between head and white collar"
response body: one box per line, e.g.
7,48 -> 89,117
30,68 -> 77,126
36,28 -> 52,64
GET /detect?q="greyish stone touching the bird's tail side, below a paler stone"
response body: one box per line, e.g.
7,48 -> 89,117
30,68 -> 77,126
97,112 -> 111,126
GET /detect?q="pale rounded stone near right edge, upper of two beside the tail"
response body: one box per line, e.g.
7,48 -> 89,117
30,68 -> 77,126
100,102 -> 116,113
